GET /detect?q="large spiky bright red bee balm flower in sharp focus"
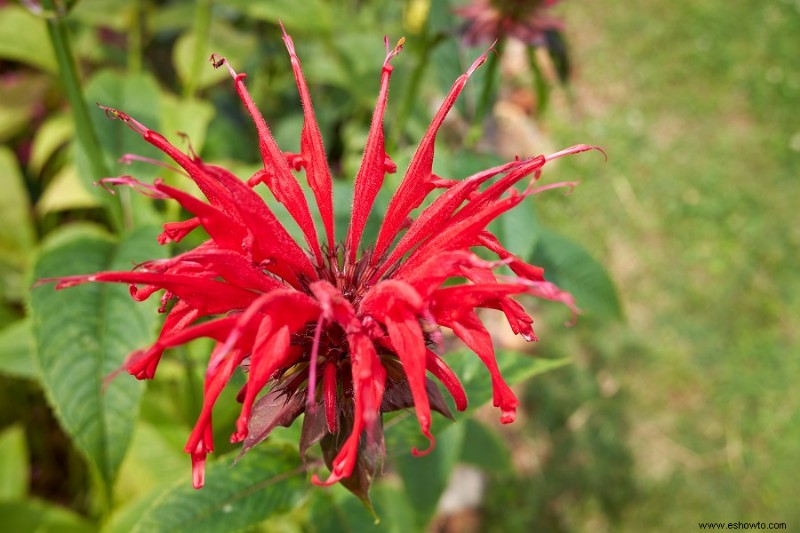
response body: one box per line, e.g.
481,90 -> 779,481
42,27 -> 590,496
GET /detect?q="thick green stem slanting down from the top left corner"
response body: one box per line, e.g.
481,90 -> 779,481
42,0 -> 123,232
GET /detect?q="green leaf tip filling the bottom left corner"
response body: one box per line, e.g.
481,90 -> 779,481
0,500 -> 97,533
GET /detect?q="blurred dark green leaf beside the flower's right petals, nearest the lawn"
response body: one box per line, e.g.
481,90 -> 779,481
532,229 -> 622,320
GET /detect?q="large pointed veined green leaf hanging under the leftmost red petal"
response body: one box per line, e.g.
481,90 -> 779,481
30,222 -> 161,488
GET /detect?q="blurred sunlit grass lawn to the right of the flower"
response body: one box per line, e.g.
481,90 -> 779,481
516,0 -> 800,531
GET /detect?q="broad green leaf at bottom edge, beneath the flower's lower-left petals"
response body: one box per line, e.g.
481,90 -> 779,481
104,445 -> 309,533
